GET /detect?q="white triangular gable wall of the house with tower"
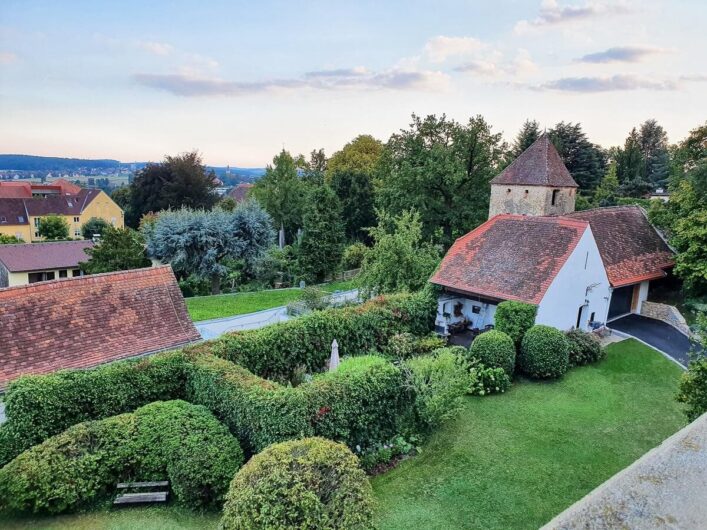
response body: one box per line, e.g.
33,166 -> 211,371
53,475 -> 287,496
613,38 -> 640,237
535,227 -> 611,330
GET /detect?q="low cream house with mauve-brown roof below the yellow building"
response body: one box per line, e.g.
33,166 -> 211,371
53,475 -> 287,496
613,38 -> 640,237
0,241 -> 93,287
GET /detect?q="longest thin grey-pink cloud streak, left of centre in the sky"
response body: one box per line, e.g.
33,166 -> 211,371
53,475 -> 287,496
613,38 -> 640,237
133,68 -> 449,97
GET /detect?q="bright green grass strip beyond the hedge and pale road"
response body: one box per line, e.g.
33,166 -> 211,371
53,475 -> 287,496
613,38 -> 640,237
184,281 -> 353,322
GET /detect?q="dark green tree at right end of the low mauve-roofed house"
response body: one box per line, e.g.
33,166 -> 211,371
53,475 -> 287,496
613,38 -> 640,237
79,225 -> 150,274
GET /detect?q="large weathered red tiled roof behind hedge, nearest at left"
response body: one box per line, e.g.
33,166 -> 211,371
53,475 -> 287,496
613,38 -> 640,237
0,266 -> 199,388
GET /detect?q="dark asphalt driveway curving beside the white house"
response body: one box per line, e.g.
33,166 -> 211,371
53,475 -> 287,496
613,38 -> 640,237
608,314 -> 696,367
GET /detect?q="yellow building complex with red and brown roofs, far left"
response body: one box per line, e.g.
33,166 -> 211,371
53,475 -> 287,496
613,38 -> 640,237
0,179 -> 123,243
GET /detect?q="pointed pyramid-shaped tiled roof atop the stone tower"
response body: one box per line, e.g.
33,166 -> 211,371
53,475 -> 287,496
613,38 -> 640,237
491,133 -> 579,188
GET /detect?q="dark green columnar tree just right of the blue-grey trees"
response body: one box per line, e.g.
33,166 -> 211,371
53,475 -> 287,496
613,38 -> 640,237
298,185 -> 344,282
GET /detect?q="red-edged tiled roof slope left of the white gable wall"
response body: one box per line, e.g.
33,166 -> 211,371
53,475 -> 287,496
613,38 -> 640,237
430,214 -> 588,304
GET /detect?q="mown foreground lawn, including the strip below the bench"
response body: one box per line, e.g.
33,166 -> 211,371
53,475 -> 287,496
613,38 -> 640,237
0,340 -> 685,530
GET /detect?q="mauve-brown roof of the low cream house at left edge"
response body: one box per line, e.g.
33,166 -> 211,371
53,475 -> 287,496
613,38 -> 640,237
0,241 -> 93,272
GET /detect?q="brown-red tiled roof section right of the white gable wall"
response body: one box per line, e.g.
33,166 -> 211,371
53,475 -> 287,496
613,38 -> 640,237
569,206 -> 675,287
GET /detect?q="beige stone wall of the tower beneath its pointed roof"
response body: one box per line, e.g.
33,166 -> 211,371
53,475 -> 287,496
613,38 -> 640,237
489,184 -> 576,219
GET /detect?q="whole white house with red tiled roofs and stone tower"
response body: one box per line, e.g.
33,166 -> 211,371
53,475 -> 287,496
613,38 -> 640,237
430,135 -> 674,334
